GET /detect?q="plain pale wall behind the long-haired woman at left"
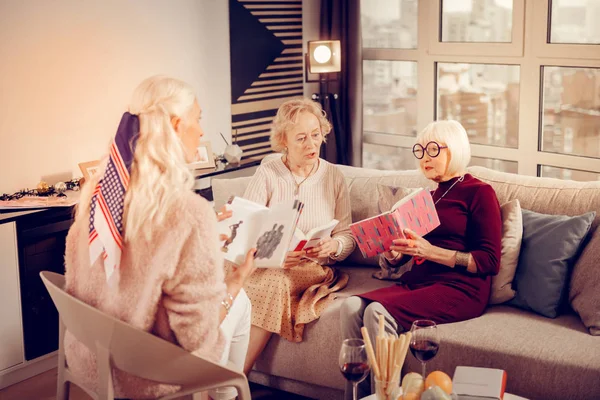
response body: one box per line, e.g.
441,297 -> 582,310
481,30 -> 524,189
0,0 -> 231,193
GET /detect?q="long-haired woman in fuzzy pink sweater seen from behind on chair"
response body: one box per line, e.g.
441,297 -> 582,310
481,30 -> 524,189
65,76 -> 254,399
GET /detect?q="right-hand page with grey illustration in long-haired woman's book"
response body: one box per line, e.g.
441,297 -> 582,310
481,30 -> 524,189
254,201 -> 298,268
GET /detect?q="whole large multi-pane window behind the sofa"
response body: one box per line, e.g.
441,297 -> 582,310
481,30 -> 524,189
361,0 -> 600,180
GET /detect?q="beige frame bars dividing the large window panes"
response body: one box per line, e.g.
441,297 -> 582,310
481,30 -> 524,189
361,0 -> 600,176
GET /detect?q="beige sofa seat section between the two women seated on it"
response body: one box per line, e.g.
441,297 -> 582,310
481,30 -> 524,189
250,266 -> 394,390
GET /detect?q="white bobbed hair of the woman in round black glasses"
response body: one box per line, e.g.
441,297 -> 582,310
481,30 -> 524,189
417,121 -> 471,176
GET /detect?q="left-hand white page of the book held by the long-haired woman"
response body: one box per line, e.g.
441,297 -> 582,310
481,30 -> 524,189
217,197 -> 269,265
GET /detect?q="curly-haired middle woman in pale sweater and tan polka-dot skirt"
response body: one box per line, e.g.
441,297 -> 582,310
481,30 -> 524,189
244,99 -> 355,374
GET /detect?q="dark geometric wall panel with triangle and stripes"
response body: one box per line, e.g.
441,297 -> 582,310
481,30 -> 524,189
229,0 -> 304,158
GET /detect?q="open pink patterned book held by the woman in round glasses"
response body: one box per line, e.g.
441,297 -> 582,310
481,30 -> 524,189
350,189 -> 440,257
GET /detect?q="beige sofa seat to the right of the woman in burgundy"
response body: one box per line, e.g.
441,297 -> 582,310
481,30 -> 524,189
404,306 -> 600,400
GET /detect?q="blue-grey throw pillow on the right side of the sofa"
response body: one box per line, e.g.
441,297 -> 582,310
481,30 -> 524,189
509,210 -> 596,318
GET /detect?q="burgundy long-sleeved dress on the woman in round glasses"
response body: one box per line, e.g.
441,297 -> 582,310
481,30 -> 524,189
359,174 -> 502,330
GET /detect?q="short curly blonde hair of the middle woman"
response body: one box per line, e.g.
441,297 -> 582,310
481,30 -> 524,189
270,97 -> 331,153
